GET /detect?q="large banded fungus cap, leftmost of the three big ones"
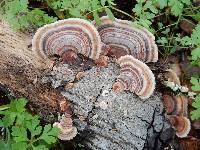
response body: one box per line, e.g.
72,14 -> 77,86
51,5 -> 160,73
32,18 -> 101,60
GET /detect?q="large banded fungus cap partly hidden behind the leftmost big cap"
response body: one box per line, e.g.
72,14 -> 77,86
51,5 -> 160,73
93,16 -> 158,62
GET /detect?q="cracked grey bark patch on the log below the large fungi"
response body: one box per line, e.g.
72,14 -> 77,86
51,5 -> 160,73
50,63 -> 171,150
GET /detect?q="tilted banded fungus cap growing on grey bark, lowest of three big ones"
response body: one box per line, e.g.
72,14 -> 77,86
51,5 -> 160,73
113,55 -> 155,99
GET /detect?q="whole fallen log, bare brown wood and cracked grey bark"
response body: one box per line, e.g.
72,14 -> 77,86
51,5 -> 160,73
0,21 -> 173,150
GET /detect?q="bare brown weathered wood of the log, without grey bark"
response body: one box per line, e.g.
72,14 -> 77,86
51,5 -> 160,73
0,20 -> 69,121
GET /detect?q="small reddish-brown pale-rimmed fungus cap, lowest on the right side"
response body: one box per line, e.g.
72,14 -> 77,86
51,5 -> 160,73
168,115 -> 191,138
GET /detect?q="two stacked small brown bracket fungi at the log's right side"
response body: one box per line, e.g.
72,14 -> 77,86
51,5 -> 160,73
163,94 -> 191,138
